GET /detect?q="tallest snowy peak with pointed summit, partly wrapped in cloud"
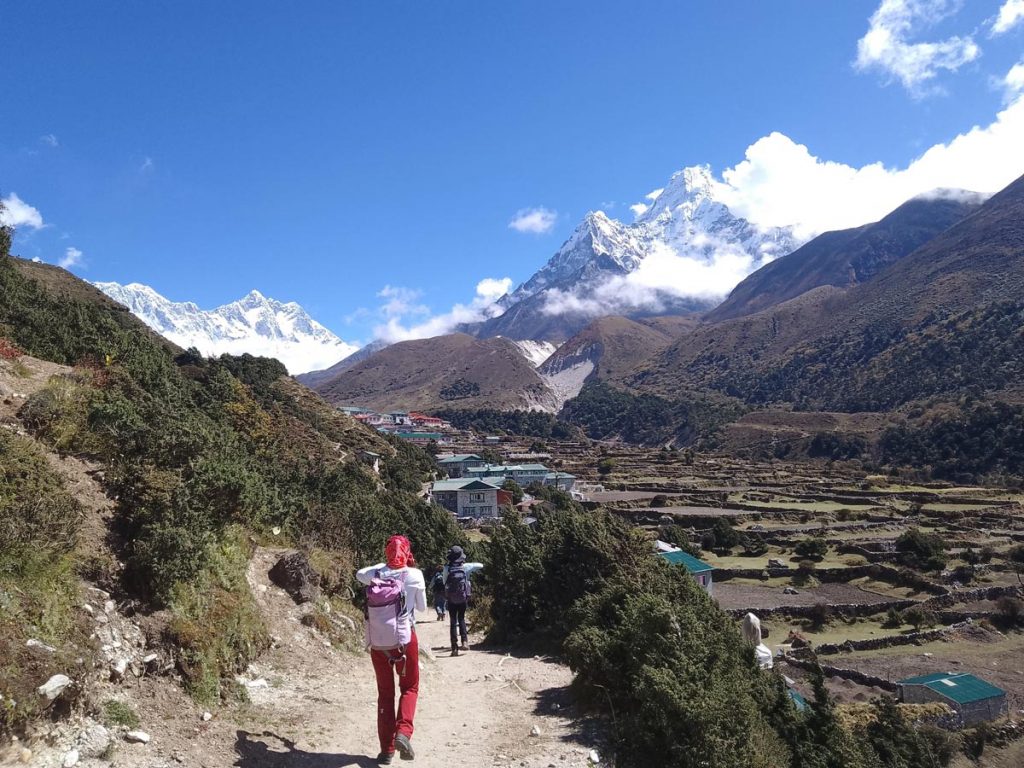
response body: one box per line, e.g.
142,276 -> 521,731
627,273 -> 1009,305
476,167 -> 800,343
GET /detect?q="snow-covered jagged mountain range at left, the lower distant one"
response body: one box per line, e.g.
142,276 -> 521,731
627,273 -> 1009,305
94,283 -> 358,374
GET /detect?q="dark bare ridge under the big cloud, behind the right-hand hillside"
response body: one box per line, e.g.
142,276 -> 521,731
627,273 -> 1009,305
705,190 -> 984,322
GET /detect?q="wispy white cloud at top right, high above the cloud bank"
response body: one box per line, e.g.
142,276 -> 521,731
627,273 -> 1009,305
854,0 -> 981,95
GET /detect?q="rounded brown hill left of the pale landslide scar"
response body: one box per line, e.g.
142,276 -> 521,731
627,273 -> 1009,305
316,334 -> 552,411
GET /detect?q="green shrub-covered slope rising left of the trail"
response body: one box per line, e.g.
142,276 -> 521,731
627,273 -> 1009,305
0,229 -> 461,729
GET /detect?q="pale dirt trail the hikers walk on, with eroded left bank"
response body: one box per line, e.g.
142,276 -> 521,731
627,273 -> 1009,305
234,551 -> 592,768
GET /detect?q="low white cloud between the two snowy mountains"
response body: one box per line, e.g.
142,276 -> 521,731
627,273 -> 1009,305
374,278 -> 512,343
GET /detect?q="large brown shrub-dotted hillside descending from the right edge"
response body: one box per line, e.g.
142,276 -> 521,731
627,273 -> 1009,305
631,172 -> 1024,411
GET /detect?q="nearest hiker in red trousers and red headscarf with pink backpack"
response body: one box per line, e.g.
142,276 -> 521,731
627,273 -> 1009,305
355,536 -> 427,765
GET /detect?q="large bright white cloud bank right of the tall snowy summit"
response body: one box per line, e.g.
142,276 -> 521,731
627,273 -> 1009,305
716,88 -> 1024,237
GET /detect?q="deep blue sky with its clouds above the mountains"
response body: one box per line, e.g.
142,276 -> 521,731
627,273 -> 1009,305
0,0 -> 1024,342
